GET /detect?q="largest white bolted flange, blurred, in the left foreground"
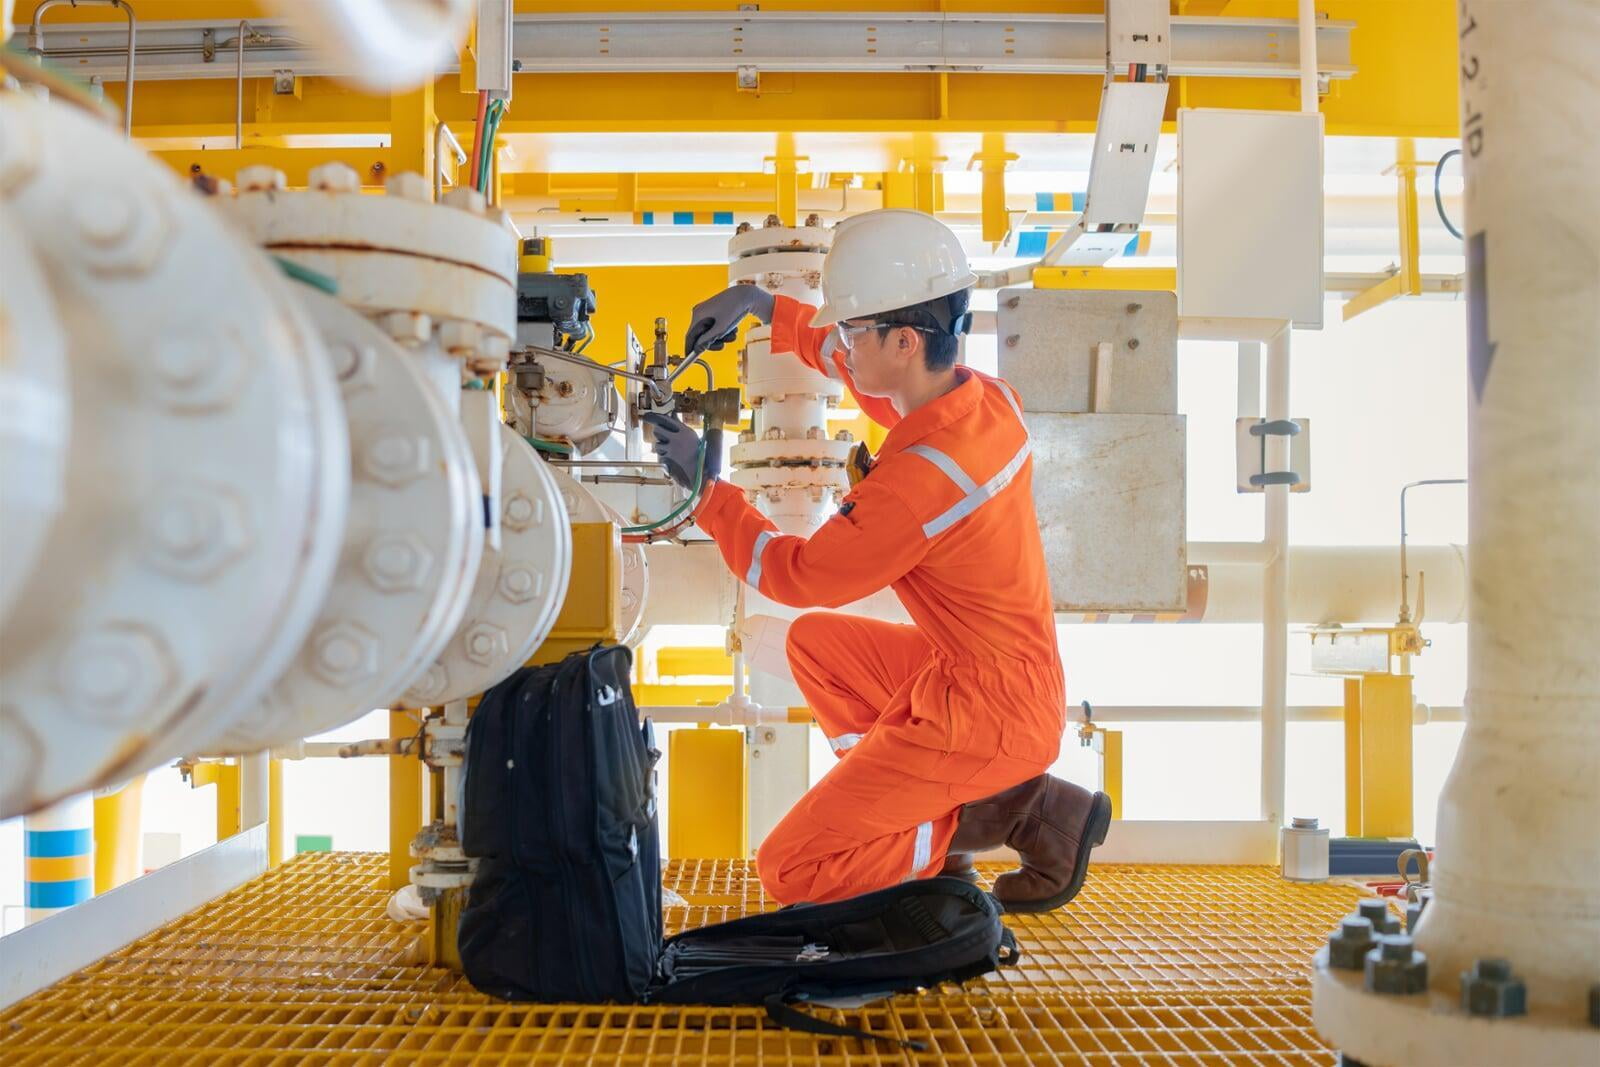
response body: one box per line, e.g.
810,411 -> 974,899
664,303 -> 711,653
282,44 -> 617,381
0,94 -> 349,816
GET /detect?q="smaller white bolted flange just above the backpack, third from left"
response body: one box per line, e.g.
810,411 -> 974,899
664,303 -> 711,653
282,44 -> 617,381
405,426 -> 573,707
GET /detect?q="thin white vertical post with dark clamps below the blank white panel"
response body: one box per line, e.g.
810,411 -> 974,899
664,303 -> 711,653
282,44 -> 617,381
1261,323 -> 1290,827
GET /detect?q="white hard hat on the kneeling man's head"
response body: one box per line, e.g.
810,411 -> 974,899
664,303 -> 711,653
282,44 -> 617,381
811,208 -> 978,326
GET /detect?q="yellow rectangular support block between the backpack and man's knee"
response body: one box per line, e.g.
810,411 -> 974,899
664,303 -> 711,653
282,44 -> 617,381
667,728 -> 750,859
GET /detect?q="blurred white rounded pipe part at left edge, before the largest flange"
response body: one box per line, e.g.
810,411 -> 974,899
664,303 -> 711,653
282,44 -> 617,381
0,209 -> 72,619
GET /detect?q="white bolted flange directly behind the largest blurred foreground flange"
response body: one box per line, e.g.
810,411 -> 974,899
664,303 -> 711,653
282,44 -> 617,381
219,290 -> 482,752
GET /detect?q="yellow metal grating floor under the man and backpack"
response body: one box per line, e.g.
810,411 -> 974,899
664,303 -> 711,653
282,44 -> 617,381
0,853 -> 1376,1067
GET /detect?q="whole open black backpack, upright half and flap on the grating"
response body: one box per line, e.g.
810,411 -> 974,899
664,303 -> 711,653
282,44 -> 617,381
458,646 -> 1018,1048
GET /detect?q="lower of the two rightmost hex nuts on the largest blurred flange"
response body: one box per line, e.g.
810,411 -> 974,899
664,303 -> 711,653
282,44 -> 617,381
139,482 -> 251,582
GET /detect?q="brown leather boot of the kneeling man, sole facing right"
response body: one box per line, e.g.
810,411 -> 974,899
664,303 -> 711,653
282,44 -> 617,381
950,774 -> 1110,912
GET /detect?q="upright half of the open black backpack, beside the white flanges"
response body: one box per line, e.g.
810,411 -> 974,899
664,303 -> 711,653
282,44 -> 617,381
458,646 -> 661,1001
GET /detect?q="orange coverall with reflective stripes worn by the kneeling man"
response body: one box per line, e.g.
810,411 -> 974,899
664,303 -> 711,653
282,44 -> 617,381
696,296 -> 1066,904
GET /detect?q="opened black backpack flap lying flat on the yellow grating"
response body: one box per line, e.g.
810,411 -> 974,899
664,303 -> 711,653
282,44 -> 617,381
645,878 -> 1018,1051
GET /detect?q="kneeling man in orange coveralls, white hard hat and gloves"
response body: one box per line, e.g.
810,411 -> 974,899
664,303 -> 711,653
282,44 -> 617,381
646,210 -> 1110,912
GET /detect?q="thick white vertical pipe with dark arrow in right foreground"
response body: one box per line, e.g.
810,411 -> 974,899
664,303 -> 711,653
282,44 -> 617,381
1418,0 -> 1600,1017
